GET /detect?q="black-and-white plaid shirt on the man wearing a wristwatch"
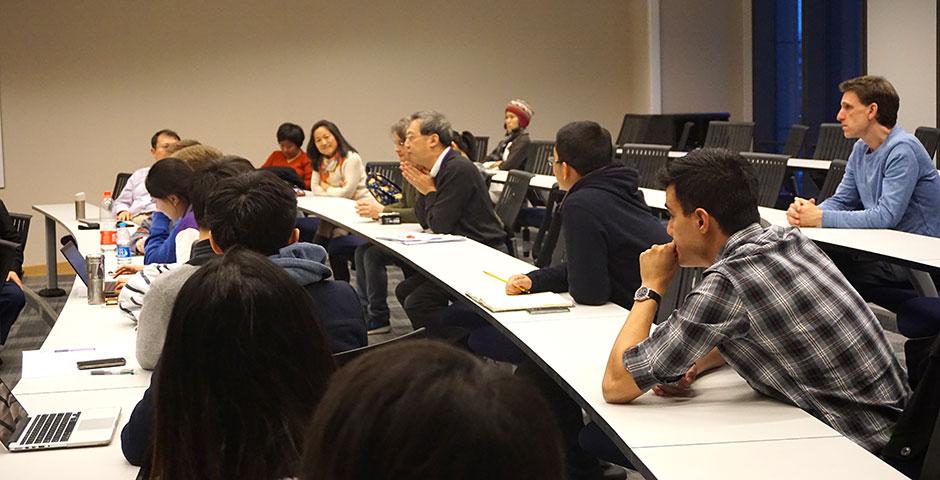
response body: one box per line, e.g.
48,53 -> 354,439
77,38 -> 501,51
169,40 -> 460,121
623,224 -> 909,452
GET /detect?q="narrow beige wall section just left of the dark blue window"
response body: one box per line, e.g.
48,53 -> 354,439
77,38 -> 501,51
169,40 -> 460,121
660,0 -> 753,120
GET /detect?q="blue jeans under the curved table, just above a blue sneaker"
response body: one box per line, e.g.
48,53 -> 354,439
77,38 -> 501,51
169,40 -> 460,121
355,243 -> 398,323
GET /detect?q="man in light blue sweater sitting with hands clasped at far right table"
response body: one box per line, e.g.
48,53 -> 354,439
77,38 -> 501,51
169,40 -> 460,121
787,76 -> 940,299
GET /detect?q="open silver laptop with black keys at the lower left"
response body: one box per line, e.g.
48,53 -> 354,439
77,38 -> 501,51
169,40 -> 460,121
0,380 -> 121,452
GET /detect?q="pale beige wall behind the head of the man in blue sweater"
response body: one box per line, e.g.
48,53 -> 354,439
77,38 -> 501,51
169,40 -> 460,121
867,0 -> 937,133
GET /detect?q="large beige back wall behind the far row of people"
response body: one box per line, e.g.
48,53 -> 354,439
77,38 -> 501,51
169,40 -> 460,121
0,0 -> 650,264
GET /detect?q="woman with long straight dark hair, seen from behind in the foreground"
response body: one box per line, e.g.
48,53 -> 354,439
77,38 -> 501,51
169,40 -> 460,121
122,248 -> 335,479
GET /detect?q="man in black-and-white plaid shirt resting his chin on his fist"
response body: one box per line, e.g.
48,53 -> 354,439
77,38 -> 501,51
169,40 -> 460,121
603,150 -> 909,452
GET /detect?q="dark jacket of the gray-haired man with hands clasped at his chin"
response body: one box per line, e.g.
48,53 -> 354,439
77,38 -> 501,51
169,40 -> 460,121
415,149 -> 506,248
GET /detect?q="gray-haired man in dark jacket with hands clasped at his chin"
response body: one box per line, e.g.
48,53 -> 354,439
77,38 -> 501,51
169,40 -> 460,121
395,111 -> 506,335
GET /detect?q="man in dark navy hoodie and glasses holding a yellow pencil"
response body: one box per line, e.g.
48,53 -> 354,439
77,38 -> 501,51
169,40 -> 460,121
506,122 -> 669,308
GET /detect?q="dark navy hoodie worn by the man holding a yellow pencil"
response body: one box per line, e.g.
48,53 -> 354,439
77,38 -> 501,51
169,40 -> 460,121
528,165 -> 670,308
